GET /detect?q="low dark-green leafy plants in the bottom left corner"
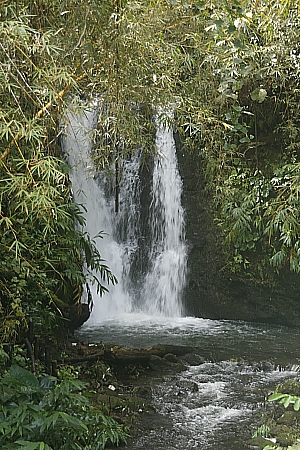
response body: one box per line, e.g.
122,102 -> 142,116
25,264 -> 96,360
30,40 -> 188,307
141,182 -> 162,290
0,366 -> 127,450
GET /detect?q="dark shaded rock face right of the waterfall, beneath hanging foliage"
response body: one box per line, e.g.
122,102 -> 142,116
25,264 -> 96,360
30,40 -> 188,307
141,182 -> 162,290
177,143 -> 300,325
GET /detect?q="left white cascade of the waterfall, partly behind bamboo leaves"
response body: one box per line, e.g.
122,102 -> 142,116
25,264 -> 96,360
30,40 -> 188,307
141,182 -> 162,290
63,109 -> 130,317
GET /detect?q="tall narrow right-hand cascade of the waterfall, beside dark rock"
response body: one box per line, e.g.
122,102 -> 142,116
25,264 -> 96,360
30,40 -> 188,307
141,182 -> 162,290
144,112 -> 186,317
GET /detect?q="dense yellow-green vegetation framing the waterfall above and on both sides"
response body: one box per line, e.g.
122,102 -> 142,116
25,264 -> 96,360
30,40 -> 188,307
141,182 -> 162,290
0,0 -> 300,348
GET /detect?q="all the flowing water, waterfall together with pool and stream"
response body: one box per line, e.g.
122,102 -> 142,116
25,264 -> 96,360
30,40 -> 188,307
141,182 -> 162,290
64,104 -> 300,450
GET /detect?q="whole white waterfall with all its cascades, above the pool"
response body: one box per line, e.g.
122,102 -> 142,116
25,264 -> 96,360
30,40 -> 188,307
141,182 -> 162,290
63,103 -> 186,324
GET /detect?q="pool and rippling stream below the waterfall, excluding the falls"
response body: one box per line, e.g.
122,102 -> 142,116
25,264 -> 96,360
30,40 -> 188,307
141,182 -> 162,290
77,314 -> 300,450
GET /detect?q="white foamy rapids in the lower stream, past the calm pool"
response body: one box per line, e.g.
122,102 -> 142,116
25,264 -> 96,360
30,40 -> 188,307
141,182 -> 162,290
129,360 -> 297,450
